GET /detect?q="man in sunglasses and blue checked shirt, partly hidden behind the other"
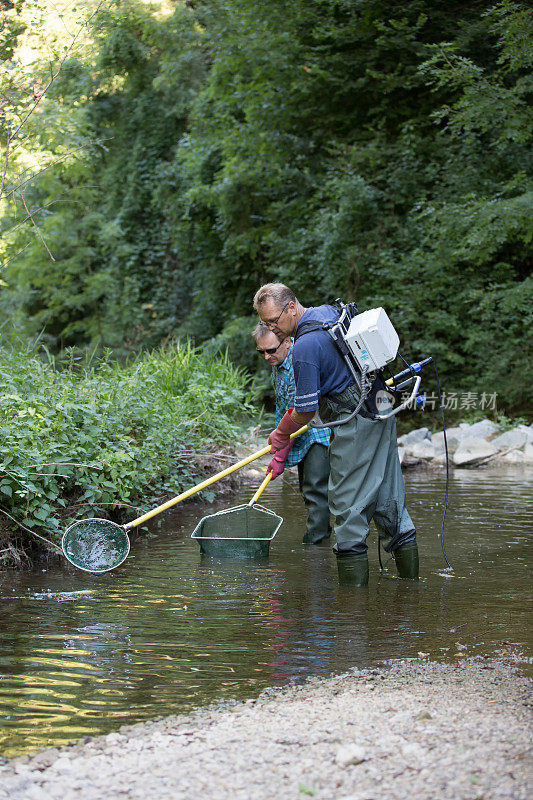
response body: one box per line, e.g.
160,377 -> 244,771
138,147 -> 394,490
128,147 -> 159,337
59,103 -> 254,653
252,322 -> 331,544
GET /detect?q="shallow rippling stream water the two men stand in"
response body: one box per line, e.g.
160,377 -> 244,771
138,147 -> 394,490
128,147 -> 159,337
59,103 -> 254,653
0,468 -> 533,755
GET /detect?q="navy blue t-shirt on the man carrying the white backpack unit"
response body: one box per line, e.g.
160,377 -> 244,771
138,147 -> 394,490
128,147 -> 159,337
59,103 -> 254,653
292,306 -> 354,414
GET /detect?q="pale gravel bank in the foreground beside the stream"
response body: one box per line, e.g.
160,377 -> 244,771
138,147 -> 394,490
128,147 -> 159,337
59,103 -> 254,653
0,659 -> 533,800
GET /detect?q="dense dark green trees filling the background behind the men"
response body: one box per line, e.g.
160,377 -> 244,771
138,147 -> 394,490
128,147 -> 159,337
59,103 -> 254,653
0,0 -> 533,409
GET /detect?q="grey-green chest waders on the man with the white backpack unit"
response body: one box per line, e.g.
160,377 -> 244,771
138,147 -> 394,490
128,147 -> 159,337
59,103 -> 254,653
295,310 -> 418,586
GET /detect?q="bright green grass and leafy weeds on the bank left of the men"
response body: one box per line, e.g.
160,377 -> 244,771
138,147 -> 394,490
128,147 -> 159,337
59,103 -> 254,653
0,345 -> 248,566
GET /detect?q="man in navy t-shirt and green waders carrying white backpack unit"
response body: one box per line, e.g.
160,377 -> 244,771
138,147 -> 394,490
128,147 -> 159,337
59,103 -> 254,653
254,283 -> 418,586
